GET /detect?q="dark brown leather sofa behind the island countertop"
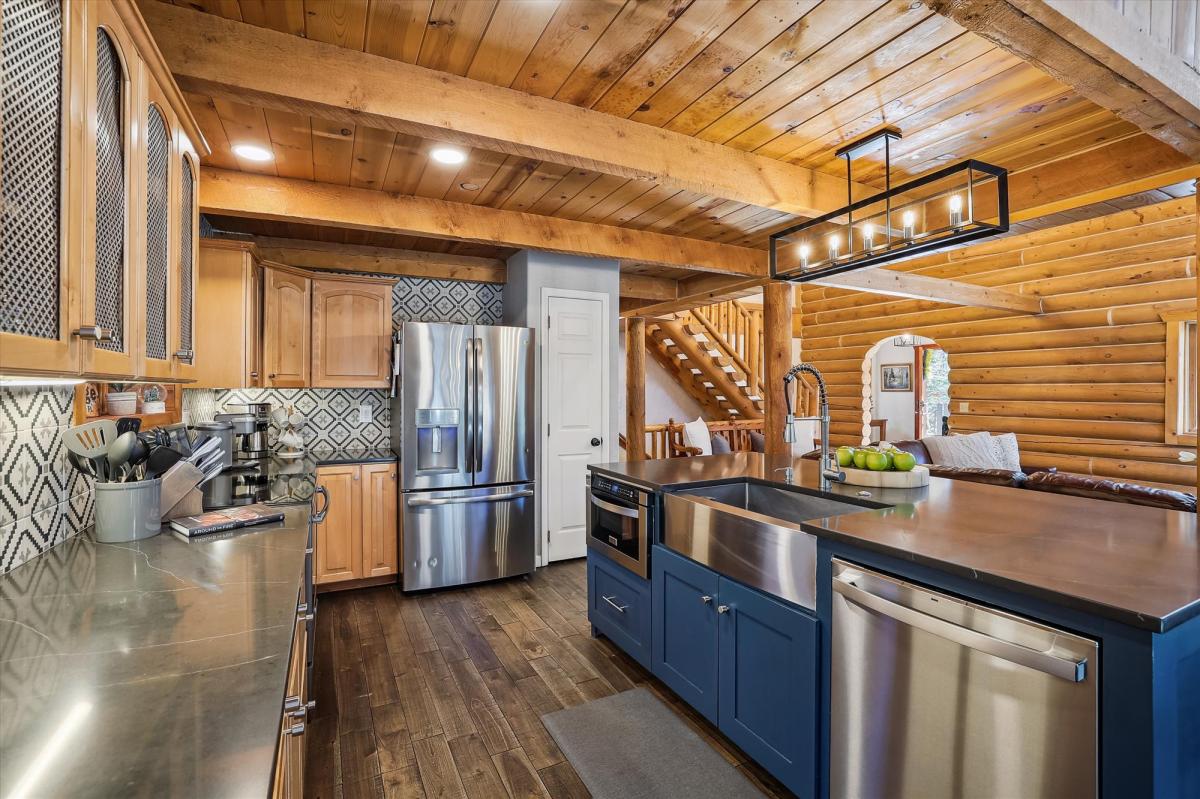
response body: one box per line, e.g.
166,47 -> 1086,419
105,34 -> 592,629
854,439 -> 1196,513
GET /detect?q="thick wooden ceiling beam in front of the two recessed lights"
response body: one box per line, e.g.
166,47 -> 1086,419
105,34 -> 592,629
143,2 -> 875,216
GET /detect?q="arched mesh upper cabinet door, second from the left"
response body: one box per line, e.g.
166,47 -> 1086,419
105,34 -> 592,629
78,4 -> 140,376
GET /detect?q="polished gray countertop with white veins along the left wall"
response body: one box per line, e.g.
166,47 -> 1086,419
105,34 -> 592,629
0,505 -> 308,798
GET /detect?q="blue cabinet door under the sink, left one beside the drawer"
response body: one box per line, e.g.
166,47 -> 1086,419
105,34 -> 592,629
650,547 -> 718,723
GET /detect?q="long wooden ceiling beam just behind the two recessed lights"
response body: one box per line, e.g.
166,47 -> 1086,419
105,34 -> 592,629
200,167 -> 767,276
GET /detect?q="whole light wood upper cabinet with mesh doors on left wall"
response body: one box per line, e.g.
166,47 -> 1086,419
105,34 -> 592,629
0,0 -> 208,379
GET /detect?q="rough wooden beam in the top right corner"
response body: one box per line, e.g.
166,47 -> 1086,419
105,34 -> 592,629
923,0 -> 1200,160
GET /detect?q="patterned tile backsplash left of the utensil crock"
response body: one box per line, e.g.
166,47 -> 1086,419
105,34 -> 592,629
0,386 -> 92,573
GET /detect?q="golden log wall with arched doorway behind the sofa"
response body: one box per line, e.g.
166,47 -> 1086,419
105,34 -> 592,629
797,197 -> 1196,491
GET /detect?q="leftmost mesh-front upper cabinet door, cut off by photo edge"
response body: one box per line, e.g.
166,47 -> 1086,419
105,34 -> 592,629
0,0 -> 83,372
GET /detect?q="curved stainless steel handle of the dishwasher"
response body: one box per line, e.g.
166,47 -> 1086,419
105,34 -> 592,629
833,577 -> 1087,683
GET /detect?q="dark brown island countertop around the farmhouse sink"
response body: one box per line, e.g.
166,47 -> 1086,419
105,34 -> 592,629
590,452 -> 1200,632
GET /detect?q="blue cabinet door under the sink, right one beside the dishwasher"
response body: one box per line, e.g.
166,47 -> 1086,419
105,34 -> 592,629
718,577 -> 820,797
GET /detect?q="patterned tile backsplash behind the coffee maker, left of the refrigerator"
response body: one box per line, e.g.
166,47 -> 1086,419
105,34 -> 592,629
184,389 -> 391,450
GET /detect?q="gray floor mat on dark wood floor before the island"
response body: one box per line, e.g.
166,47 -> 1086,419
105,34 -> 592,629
541,687 -> 762,799
